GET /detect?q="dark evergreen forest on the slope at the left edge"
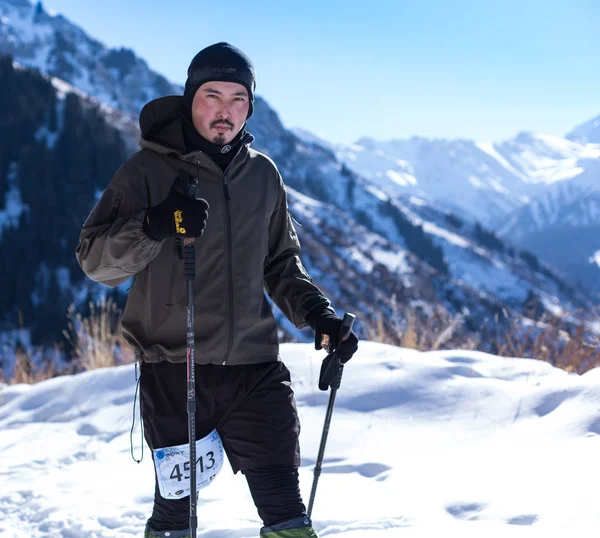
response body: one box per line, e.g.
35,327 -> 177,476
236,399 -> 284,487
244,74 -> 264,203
0,57 -> 127,344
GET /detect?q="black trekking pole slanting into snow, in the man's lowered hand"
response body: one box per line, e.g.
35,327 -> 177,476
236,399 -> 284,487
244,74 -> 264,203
307,312 -> 356,518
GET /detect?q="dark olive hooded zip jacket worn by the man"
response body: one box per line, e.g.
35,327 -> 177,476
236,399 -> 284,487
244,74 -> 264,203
76,96 -> 329,365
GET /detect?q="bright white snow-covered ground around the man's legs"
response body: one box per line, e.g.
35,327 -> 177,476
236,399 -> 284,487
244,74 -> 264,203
0,342 -> 600,538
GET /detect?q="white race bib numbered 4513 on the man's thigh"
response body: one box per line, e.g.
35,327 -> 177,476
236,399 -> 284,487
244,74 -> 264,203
153,430 -> 223,499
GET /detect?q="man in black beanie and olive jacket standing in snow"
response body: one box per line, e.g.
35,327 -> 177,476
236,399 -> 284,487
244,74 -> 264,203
77,43 -> 358,538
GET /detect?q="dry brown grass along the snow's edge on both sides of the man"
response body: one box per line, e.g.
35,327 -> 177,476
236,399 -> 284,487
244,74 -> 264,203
0,299 -> 600,384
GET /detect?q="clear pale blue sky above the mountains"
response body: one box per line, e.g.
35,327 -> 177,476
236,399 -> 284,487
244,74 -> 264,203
44,0 -> 600,142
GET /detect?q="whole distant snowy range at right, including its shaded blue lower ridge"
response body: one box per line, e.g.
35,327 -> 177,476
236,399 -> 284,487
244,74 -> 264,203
295,120 -> 600,289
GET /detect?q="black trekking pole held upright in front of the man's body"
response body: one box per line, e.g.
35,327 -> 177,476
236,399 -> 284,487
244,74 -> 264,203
183,239 -> 198,538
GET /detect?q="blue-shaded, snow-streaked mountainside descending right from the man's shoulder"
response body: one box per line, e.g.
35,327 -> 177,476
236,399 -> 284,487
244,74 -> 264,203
250,100 -> 586,330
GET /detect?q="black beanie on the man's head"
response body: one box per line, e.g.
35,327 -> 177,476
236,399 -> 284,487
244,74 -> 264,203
183,42 -> 256,119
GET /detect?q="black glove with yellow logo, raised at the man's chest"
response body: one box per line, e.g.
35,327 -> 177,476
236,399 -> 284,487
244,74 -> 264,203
144,180 -> 208,241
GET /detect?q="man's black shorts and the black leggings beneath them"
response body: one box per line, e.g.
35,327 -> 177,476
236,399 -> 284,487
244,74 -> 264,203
140,362 -> 306,531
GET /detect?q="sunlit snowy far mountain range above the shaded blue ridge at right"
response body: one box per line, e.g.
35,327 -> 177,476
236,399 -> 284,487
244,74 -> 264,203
310,130 -> 600,227
